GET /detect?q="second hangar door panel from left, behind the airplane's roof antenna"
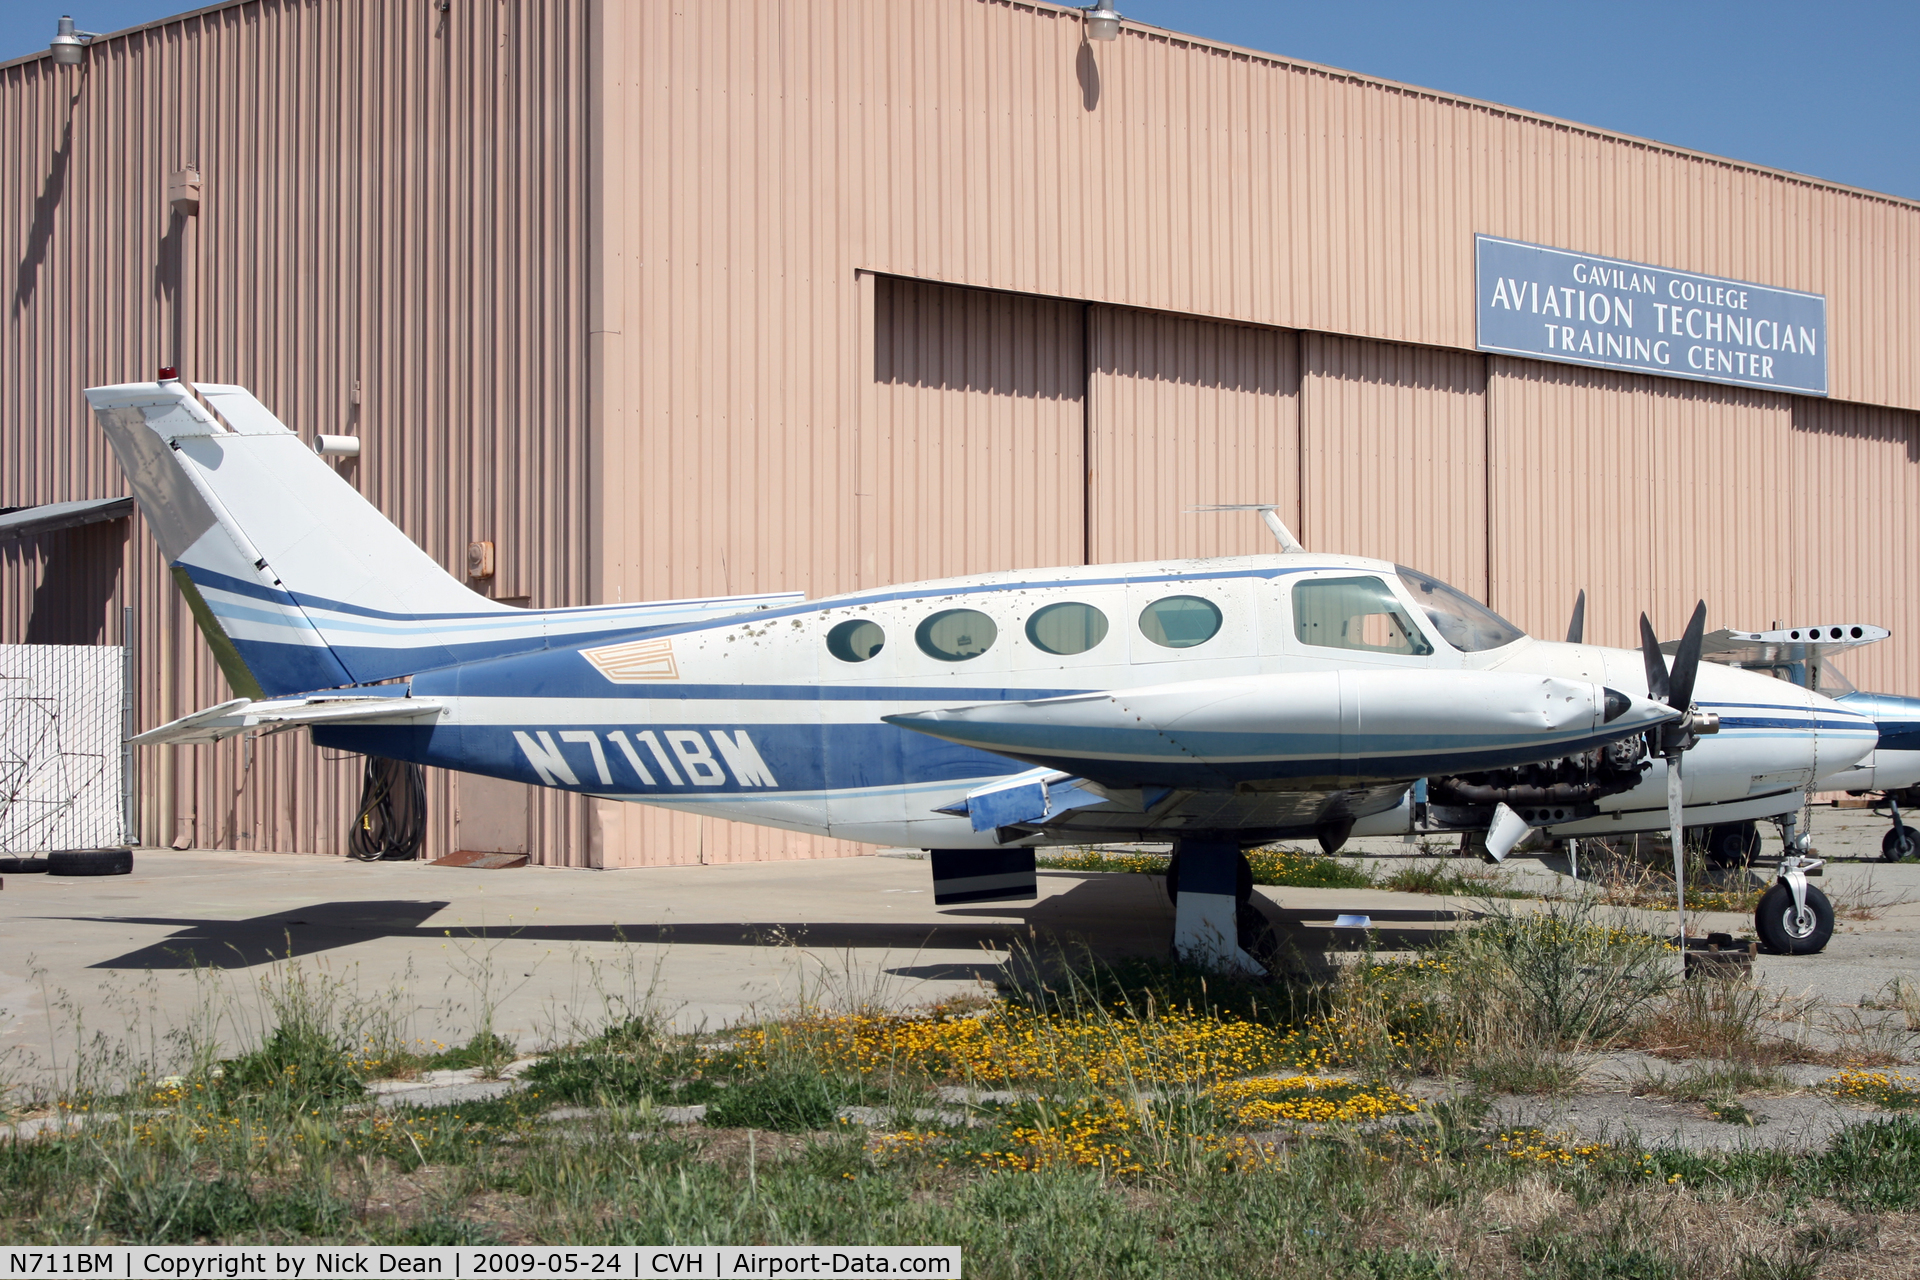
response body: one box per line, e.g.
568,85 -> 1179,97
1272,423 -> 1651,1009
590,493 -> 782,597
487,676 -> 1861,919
1087,307 -> 1300,564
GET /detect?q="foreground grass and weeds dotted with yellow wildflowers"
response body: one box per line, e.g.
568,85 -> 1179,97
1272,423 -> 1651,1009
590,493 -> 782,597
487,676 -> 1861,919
0,904 -> 1920,1278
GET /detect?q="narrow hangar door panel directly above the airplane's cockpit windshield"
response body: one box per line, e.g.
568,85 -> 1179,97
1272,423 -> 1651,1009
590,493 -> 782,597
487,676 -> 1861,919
1296,334 -> 1488,601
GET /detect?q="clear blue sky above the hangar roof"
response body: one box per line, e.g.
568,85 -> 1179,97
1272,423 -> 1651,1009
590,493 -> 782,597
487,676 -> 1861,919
0,0 -> 1920,200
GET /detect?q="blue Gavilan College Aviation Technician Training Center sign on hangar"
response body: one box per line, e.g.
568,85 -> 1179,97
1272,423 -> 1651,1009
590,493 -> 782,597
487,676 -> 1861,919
1473,236 -> 1826,395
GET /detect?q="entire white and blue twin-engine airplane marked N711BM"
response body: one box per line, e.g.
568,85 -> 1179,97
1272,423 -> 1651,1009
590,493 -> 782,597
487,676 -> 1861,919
97,380 -> 1878,969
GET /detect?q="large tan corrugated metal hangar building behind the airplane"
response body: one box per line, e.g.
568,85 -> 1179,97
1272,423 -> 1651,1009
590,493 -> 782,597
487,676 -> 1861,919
0,0 -> 1920,867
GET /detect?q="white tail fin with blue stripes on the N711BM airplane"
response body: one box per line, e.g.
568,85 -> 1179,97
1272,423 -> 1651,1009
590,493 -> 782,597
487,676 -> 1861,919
86,382 -> 795,699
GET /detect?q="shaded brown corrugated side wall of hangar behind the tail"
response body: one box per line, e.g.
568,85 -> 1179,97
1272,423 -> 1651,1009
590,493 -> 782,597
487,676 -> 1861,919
0,0 -> 588,862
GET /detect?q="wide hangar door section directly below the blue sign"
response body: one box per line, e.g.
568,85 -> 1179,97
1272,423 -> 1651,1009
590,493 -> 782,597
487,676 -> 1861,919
1490,357 -> 1920,691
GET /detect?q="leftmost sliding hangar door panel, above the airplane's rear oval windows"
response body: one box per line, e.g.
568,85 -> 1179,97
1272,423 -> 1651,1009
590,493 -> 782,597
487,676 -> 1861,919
856,276 -> 1087,587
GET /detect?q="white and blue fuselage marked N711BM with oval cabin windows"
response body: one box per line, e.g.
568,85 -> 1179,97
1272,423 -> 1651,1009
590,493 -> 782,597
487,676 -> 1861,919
315,553 -> 1878,848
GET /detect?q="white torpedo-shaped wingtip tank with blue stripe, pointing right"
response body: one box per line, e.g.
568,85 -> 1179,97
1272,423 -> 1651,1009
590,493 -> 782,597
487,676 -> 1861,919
885,670 -> 1678,790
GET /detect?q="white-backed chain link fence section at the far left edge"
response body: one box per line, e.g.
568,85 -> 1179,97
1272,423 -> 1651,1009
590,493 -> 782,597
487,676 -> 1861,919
0,645 -> 134,856
